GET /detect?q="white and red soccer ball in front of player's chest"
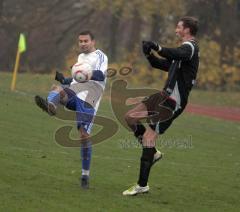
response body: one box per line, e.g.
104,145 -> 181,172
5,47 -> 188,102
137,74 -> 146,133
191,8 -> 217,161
72,63 -> 92,82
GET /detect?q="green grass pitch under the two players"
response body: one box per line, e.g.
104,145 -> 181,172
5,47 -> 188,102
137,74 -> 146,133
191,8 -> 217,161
0,73 -> 240,212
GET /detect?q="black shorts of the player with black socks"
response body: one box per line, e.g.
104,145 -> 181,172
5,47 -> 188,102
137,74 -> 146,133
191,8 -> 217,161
142,92 -> 183,134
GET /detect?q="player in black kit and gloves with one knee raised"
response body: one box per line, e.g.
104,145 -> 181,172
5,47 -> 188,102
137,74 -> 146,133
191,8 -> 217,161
123,16 -> 199,196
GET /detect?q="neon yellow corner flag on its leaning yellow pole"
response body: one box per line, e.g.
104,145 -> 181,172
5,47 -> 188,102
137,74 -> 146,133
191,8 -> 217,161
11,33 -> 27,91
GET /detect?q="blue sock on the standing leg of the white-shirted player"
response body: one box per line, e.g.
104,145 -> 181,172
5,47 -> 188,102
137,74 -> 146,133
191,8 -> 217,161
81,140 -> 92,177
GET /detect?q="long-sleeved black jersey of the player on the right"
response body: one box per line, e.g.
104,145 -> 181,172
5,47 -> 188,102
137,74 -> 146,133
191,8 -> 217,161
148,40 -> 199,109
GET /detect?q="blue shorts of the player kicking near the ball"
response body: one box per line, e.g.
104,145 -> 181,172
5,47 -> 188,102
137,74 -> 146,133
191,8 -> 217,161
64,89 -> 95,134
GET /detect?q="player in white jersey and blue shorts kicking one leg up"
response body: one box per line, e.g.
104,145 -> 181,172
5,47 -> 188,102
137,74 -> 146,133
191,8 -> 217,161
35,31 -> 108,188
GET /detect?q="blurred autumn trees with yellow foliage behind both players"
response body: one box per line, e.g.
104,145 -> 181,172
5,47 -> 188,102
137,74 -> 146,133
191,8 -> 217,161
0,0 -> 240,90
